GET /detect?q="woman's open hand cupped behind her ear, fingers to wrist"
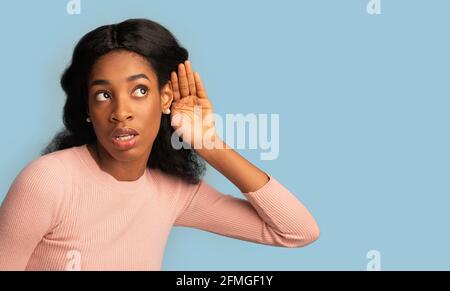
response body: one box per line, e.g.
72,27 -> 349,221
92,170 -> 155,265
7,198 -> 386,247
170,61 -> 218,150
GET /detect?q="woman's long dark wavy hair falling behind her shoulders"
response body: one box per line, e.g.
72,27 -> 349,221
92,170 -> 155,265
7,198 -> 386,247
41,19 -> 206,184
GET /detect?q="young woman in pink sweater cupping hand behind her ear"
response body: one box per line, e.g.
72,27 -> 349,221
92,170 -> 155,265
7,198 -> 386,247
0,19 -> 319,270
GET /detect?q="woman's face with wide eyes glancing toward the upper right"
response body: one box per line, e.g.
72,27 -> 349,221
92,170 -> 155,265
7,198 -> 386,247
88,50 -> 173,164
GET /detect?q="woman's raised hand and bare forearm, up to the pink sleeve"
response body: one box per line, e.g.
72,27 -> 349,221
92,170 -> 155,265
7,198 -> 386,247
170,61 -> 269,193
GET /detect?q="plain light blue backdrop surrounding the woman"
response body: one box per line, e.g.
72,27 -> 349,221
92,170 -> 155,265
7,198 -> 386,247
0,0 -> 450,270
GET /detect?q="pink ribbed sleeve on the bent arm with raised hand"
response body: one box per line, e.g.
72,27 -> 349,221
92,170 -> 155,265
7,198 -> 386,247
175,173 -> 320,248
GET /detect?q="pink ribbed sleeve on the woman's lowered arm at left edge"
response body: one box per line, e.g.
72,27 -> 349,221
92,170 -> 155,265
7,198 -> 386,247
0,157 -> 64,270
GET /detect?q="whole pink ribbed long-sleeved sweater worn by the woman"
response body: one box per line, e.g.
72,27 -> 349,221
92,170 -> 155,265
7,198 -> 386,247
0,145 -> 319,270
